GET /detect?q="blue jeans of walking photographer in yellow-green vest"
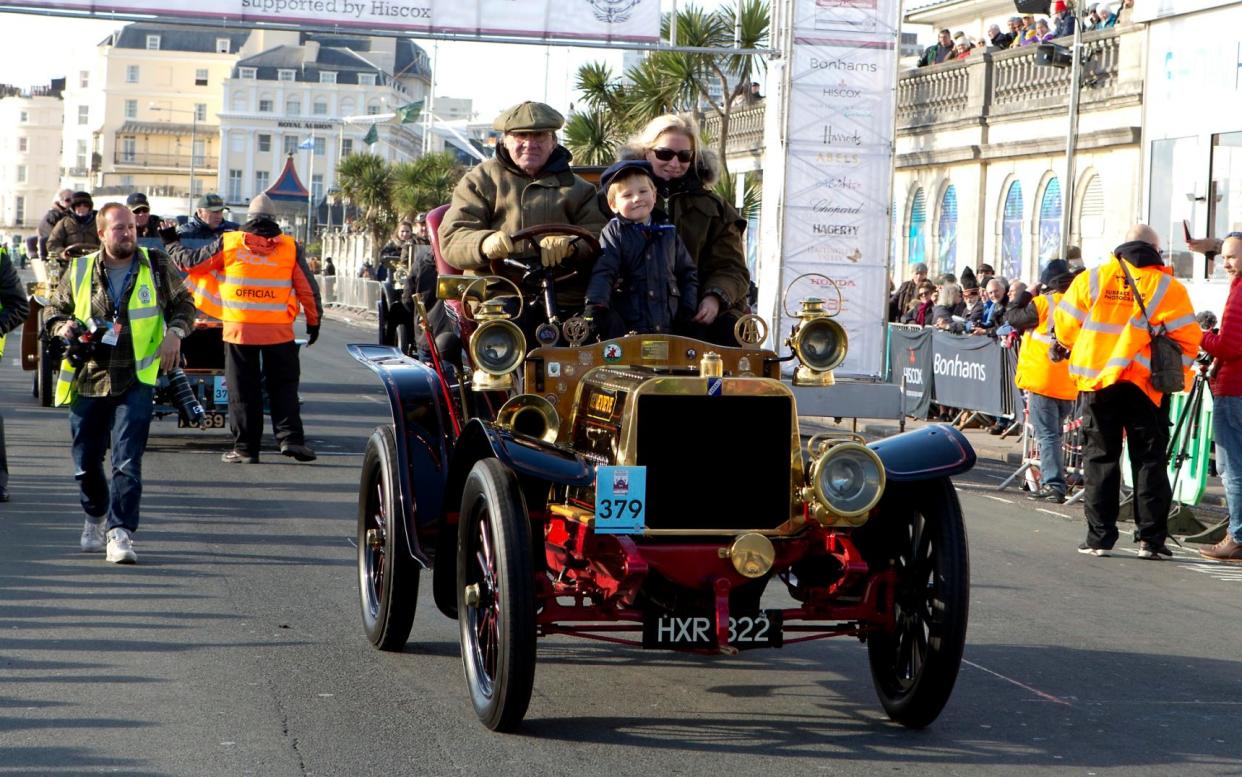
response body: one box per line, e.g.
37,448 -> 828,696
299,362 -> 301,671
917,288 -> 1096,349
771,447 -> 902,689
70,382 -> 155,531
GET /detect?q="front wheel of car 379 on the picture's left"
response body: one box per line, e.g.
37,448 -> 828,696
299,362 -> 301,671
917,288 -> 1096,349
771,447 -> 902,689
457,459 -> 535,731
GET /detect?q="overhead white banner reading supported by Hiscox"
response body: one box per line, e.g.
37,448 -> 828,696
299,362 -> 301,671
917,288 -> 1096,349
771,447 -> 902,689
5,0 -> 660,42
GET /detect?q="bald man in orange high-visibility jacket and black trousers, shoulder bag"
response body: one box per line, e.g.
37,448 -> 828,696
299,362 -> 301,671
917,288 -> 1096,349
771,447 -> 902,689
1056,225 -> 1202,559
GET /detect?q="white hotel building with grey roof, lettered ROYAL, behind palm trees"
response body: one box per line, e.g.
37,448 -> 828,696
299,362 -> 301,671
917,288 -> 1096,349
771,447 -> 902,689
216,32 -> 430,211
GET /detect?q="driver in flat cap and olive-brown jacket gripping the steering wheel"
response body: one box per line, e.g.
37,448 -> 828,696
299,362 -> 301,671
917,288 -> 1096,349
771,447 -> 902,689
440,102 -> 607,317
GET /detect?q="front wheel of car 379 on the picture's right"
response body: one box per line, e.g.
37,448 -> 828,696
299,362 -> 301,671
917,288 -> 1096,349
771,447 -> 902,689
864,479 -> 970,729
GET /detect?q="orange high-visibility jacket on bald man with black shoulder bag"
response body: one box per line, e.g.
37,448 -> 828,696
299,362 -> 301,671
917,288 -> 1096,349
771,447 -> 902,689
1056,249 -> 1202,405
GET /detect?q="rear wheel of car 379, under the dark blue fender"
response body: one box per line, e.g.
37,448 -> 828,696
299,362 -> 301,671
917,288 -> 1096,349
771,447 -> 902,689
358,426 -> 419,650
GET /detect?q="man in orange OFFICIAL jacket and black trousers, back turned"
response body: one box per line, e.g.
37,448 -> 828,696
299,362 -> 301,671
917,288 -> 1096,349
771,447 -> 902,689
160,194 -> 323,464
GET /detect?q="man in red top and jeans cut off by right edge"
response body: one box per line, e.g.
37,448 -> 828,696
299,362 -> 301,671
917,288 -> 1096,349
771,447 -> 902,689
1199,232 -> 1242,562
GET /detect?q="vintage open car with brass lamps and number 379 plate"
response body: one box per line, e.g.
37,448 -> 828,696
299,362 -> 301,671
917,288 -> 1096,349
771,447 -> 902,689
349,222 -> 975,731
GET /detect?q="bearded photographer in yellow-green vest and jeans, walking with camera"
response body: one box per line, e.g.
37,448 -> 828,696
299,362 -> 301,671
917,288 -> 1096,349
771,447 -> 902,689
48,202 -> 194,564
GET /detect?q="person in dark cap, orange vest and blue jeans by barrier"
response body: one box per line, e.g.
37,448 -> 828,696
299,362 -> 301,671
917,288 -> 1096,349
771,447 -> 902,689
1007,259 -> 1078,504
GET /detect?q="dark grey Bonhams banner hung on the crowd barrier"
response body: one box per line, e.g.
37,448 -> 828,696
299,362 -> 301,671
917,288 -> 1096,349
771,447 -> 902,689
932,330 -> 1012,416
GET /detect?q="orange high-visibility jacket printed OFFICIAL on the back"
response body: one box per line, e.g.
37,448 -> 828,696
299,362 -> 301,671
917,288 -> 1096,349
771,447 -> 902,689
166,231 -> 323,345
